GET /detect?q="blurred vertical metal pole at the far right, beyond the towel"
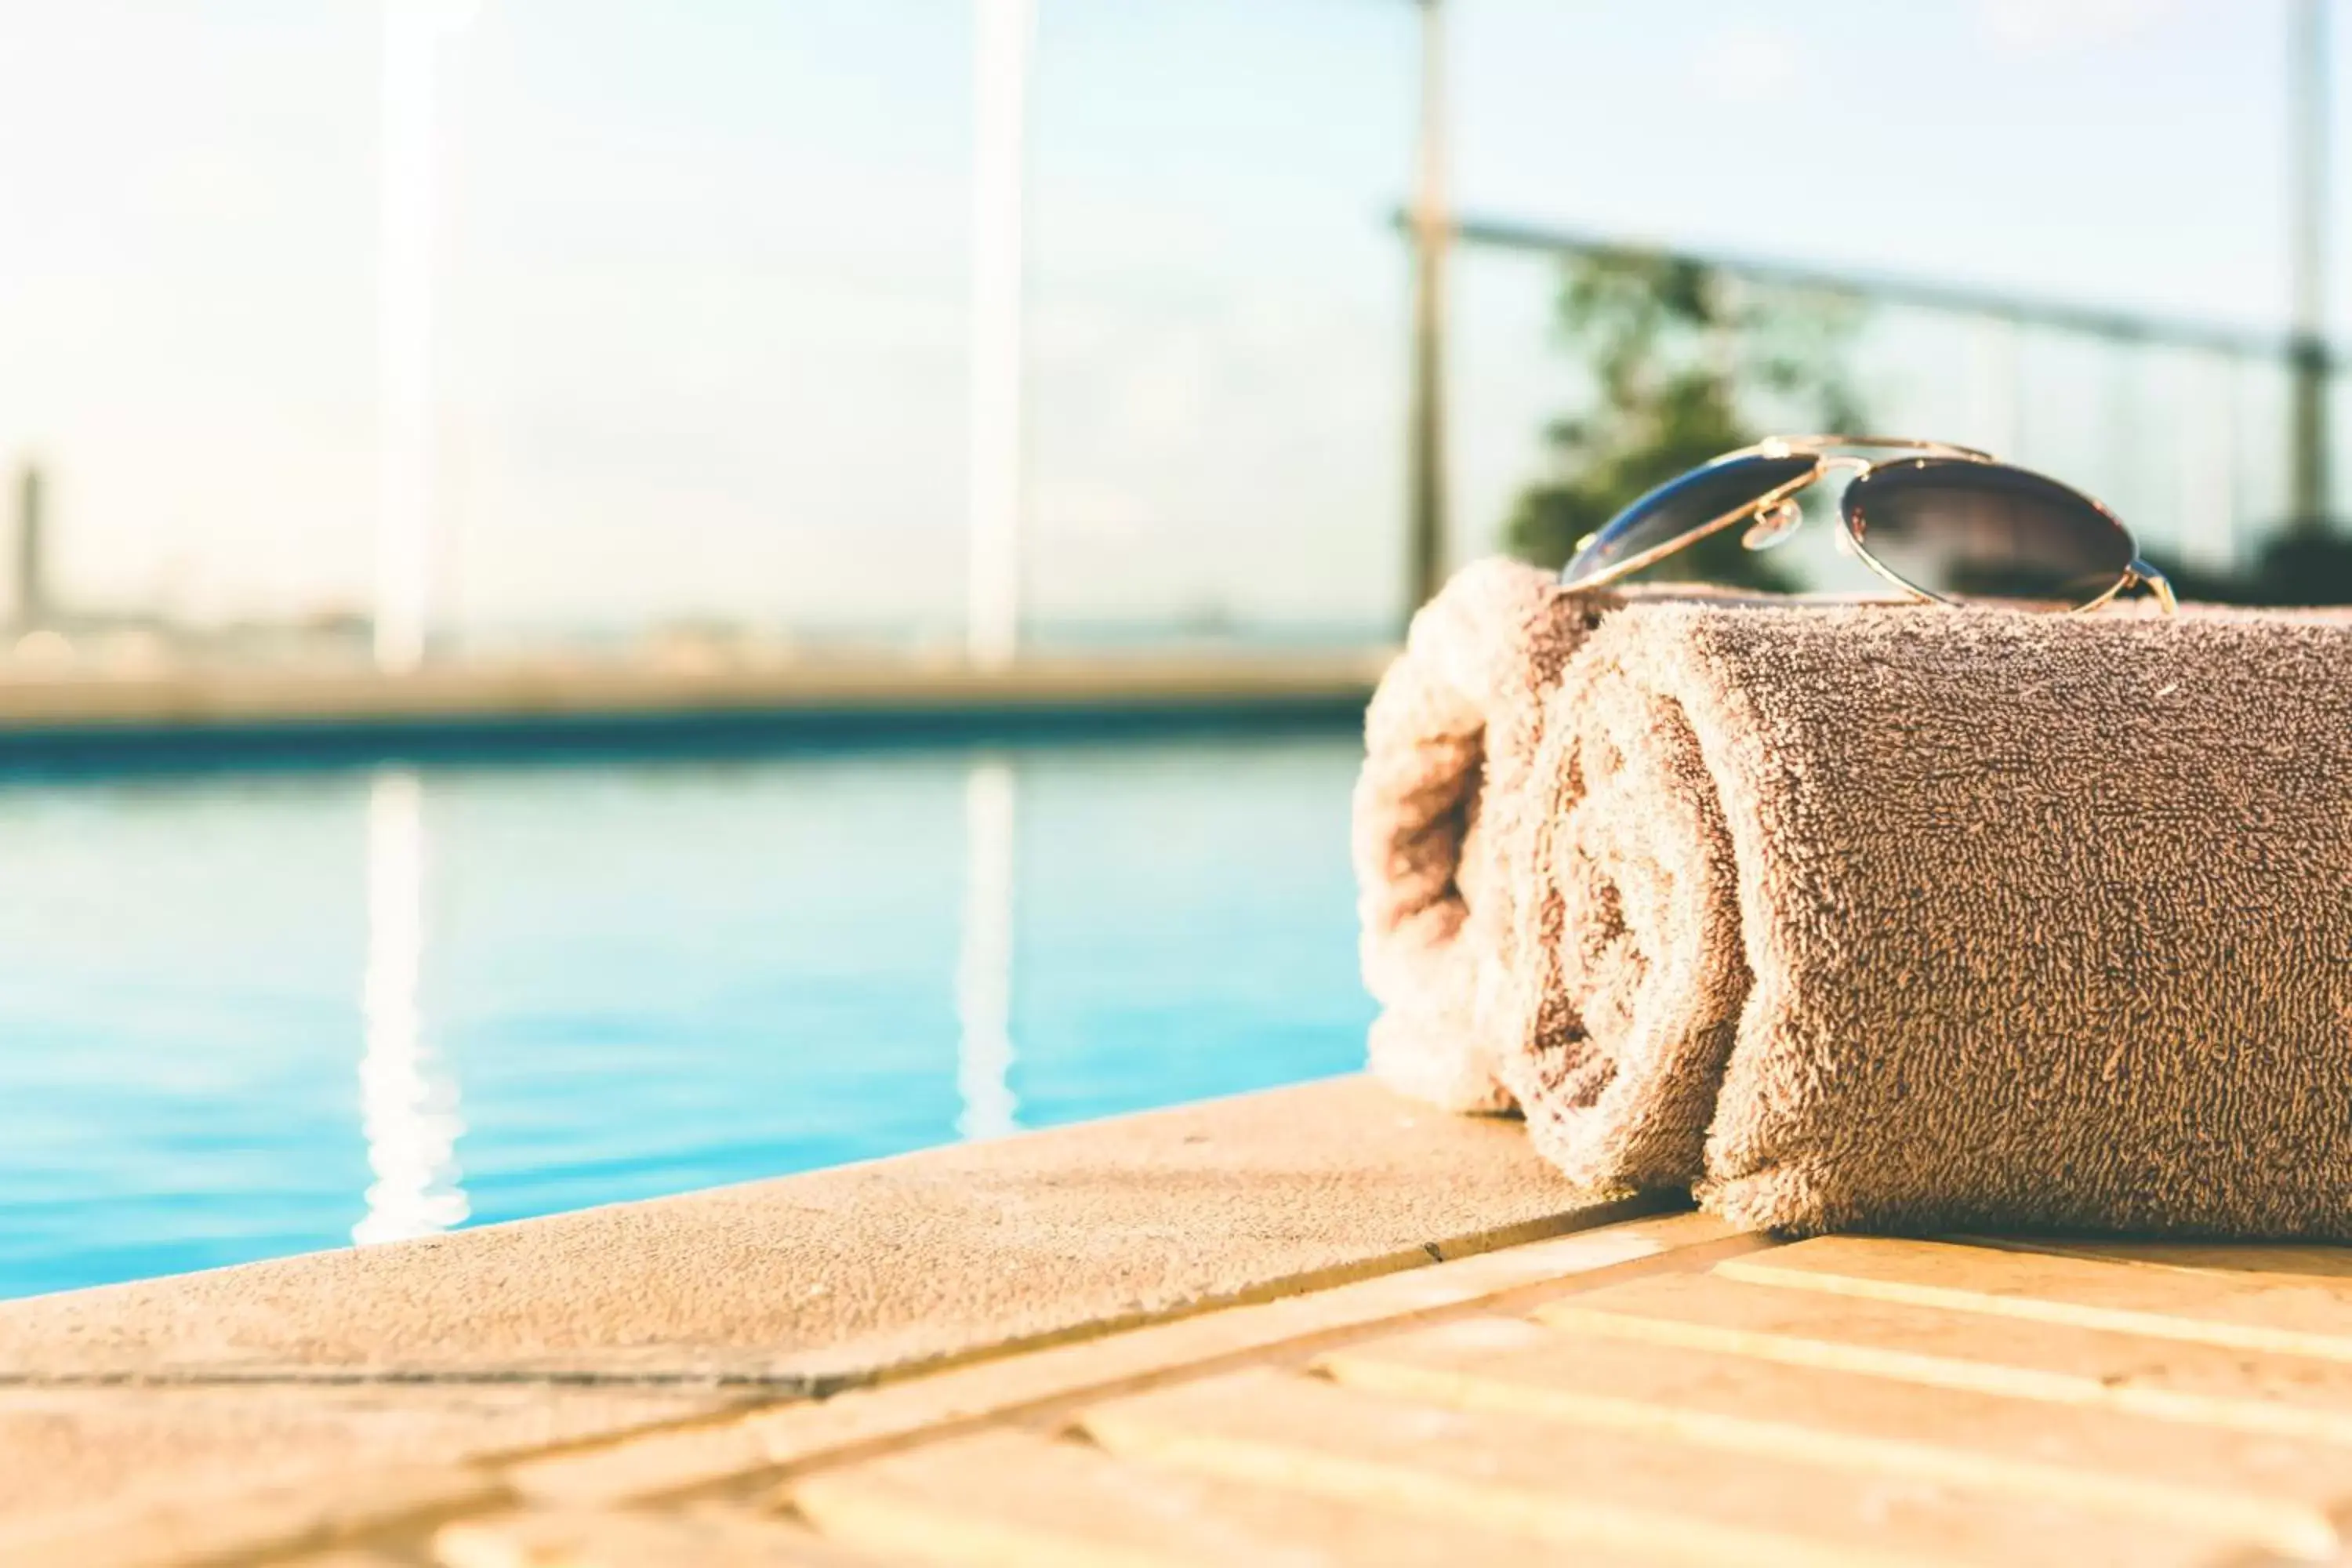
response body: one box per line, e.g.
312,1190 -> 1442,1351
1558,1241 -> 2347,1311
2288,0 -> 2328,529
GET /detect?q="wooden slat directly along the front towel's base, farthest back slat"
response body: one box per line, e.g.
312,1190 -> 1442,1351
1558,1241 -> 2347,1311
1717,1236 -> 2352,1361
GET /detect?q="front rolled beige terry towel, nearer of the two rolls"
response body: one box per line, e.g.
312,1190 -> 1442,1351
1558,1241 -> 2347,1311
1494,604 -> 2352,1239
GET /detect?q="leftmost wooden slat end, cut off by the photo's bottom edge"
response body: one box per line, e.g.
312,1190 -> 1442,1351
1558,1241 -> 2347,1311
433,1504 -> 875,1568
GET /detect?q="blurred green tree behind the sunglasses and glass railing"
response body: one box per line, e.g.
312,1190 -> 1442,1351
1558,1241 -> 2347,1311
1505,252 -> 1865,590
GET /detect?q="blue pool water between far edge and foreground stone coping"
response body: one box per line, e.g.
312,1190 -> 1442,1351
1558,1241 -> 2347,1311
0,734 -> 1369,1295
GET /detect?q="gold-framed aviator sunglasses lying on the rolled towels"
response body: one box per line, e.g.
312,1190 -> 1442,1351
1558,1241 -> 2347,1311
1559,435 -> 2173,612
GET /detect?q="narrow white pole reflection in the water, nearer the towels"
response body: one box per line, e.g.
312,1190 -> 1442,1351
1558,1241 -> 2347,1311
955,757 -> 1021,1138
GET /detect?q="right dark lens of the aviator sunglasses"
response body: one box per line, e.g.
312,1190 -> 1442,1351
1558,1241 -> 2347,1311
1844,459 -> 2133,604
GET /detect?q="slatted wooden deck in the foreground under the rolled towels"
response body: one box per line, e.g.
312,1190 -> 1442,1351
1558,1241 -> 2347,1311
313,1215 -> 2352,1568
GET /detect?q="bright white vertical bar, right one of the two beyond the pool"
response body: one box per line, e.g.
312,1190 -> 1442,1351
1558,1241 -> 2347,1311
964,0 -> 1037,668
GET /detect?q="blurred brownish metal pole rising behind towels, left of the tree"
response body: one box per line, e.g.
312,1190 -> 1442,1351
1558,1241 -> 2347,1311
1404,0 -> 1454,616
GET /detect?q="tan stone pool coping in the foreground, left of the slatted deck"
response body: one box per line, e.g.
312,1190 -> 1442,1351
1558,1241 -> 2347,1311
0,1076 -> 1630,1563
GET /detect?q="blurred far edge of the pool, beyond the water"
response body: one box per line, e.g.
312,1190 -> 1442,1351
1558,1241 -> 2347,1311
0,649 -> 1392,769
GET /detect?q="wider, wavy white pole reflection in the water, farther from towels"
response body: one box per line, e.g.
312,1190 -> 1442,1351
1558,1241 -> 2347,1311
350,769 -> 468,1243
